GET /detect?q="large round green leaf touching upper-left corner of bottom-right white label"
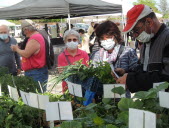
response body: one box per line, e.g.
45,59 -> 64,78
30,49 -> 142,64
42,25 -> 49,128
118,98 -> 134,111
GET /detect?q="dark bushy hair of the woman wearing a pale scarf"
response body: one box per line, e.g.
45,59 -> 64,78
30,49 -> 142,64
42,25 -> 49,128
95,21 -> 121,43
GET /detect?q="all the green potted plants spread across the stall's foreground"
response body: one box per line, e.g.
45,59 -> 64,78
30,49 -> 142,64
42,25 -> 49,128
0,62 -> 169,128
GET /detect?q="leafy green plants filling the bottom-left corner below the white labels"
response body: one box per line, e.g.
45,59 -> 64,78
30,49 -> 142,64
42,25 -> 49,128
0,96 -> 44,128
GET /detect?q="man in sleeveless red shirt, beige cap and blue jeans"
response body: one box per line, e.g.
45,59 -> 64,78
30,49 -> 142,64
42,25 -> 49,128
11,20 -> 48,91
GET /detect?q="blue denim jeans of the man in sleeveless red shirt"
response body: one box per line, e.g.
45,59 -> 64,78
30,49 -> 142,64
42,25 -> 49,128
25,67 -> 48,92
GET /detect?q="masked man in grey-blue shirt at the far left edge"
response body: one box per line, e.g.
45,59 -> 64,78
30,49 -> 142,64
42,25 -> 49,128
0,25 -> 21,76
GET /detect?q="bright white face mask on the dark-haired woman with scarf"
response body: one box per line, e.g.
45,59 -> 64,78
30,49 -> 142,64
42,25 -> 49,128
100,39 -> 116,50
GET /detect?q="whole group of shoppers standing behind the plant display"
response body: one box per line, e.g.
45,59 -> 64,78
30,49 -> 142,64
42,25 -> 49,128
0,4 -> 169,102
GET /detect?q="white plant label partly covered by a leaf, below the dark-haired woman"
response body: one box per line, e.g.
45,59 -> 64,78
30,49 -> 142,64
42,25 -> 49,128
103,84 -> 125,98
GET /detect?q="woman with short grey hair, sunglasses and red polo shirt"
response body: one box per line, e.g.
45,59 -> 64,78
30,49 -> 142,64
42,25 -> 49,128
58,30 -> 89,92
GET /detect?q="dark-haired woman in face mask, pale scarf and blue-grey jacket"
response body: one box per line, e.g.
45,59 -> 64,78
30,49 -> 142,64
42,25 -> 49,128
92,21 -> 138,97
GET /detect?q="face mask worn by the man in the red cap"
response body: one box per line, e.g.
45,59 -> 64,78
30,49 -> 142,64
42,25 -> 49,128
136,31 -> 154,43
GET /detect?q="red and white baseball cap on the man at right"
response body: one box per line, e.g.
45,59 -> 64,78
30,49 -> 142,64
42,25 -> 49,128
123,4 -> 153,33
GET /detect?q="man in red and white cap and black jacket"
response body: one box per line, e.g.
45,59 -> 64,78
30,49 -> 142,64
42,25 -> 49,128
116,4 -> 169,92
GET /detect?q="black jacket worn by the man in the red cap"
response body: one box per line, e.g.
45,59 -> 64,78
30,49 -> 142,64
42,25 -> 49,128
126,24 -> 169,92
